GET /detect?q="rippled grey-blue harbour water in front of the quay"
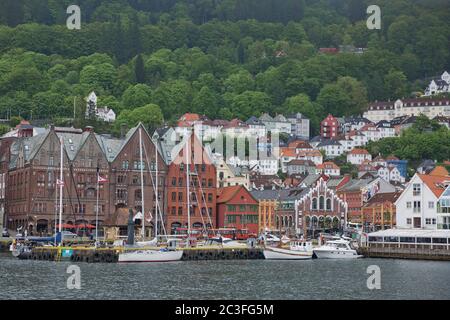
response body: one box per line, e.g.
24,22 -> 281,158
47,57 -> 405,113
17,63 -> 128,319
0,254 -> 450,299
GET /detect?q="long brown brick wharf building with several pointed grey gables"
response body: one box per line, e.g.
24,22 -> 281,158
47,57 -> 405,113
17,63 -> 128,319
0,125 -> 167,234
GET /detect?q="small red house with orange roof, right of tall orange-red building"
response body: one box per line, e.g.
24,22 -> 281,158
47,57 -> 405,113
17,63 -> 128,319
217,186 -> 258,234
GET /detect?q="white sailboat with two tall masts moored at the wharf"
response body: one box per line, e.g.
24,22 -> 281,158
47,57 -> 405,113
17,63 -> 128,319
119,125 -> 183,263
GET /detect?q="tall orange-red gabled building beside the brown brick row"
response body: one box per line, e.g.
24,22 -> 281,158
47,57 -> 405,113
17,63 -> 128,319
166,134 -> 217,232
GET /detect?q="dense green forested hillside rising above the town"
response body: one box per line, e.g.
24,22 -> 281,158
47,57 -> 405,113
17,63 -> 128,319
0,0 -> 450,133
